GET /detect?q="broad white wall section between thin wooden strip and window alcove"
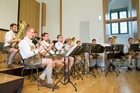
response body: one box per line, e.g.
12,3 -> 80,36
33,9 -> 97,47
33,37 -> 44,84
62,0 -> 104,43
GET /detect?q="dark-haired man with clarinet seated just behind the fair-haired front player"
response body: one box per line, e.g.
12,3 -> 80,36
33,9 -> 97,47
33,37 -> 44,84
40,33 -> 63,78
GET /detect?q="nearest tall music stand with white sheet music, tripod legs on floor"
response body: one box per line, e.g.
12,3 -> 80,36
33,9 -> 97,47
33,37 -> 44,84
52,46 -> 79,91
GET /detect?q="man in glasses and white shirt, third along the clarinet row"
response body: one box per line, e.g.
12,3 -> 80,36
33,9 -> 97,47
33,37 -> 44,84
55,35 -> 74,74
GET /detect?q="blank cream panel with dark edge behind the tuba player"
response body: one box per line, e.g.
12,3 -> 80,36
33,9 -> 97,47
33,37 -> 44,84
0,0 -> 18,30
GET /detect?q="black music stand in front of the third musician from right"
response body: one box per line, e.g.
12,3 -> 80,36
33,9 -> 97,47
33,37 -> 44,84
91,44 -> 105,72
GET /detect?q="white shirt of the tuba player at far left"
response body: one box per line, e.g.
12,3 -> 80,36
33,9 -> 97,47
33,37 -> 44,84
4,30 -> 16,47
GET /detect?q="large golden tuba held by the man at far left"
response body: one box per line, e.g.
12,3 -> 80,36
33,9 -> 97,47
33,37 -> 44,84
12,21 -> 28,49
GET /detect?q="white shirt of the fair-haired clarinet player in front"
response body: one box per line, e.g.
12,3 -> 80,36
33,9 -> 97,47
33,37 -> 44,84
18,37 -> 38,59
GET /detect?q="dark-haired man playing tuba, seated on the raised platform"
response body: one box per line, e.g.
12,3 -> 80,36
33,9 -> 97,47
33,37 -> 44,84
3,23 -> 20,68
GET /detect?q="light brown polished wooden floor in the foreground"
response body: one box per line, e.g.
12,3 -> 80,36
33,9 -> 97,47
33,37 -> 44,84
22,68 -> 140,93
